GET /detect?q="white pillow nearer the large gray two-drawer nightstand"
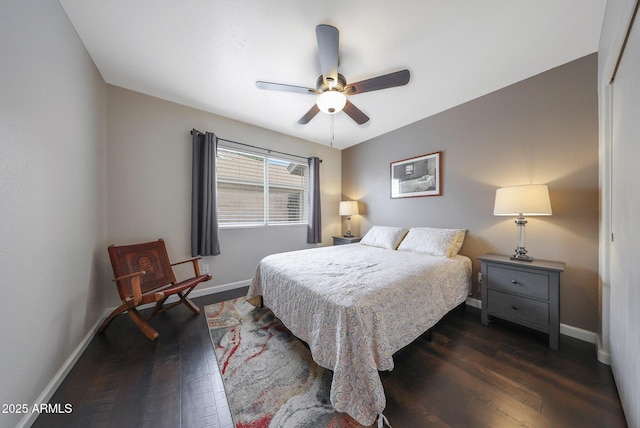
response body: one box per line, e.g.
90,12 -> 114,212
398,227 -> 465,257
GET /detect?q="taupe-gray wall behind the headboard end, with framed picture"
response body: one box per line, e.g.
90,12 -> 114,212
342,54 -> 598,332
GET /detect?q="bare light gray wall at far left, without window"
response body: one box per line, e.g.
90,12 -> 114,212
0,0 -> 107,427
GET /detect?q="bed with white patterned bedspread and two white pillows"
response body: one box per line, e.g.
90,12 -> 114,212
247,226 -> 471,425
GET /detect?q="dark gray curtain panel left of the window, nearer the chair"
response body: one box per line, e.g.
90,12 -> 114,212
191,129 -> 220,257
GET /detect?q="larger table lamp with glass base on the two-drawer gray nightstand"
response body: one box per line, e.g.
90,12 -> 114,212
493,184 -> 551,262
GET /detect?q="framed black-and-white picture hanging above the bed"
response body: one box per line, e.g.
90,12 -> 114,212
391,152 -> 442,198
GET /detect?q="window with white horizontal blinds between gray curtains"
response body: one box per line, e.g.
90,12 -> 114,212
217,147 -> 309,226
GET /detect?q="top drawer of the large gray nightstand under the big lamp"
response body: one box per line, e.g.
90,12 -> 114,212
487,265 -> 549,300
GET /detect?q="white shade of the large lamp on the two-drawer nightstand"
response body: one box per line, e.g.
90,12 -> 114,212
493,184 -> 551,216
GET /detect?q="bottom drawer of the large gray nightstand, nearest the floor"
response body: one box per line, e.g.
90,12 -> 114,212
487,290 -> 549,331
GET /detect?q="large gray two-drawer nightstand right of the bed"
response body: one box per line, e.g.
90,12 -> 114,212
478,254 -> 565,351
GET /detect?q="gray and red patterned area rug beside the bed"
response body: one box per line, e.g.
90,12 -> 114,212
205,297 -> 362,428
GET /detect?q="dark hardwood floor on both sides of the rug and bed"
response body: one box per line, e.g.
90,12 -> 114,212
33,289 -> 626,428
